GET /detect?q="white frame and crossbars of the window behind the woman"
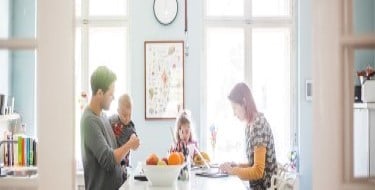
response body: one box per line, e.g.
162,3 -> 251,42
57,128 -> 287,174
200,0 -> 299,163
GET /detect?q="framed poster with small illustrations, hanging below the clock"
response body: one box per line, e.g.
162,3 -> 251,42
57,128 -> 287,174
144,41 -> 184,119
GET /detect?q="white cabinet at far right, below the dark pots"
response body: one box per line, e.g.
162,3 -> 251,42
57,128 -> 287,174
353,103 -> 375,177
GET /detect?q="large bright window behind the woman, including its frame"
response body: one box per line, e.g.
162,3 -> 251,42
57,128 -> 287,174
204,0 -> 297,163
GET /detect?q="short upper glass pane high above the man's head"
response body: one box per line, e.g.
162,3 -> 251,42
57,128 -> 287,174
89,0 -> 127,16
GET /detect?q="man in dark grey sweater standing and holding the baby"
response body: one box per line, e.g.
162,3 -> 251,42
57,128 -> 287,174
81,66 -> 139,190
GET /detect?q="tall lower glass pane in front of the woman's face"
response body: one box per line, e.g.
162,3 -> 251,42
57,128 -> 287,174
206,27 -> 245,162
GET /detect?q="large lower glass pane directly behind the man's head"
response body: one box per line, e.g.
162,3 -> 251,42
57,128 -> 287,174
88,27 -> 127,113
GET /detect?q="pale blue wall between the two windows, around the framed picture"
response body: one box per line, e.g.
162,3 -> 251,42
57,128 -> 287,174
130,0 -> 203,164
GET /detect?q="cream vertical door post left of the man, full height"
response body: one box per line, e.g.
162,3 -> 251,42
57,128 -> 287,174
36,0 -> 75,190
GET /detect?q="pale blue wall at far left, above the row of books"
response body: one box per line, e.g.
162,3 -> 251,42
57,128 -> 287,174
10,0 -> 36,136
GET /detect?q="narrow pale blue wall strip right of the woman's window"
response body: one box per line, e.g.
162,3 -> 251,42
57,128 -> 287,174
298,0 -> 314,190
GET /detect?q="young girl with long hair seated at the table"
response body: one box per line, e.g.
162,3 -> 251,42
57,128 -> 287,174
171,110 -> 198,159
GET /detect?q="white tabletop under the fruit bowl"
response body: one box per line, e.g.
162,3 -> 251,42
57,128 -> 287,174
120,171 -> 250,190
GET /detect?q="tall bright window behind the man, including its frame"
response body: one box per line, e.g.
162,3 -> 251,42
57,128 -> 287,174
75,0 -> 129,168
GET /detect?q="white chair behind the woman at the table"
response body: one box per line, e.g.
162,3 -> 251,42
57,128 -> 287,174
267,164 -> 298,190
